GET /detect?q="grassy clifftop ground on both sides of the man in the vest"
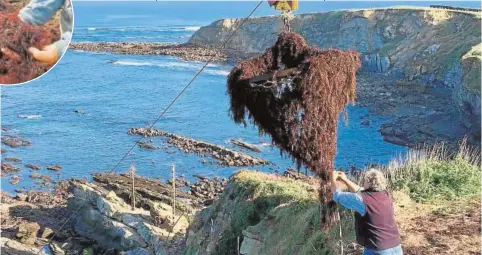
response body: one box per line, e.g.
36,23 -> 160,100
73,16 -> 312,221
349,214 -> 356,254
187,142 -> 481,254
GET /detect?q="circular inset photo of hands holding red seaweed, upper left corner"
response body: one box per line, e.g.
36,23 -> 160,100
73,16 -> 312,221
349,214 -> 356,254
0,0 -> 74,85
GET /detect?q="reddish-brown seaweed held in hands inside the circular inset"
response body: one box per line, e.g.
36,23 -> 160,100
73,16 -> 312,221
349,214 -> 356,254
0,0 -> 58,84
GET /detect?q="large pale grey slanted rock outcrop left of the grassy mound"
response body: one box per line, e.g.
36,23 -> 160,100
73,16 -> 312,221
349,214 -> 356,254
68,180 -> 189,255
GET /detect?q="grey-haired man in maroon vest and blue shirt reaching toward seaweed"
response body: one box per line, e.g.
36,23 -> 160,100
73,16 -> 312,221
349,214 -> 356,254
331,169 -> 403,255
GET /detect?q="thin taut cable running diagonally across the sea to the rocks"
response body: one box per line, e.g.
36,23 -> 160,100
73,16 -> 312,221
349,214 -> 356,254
36,0 -> 264,255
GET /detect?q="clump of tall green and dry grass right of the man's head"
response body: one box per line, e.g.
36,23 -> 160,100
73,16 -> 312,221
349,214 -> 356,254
378,139 -> 481,203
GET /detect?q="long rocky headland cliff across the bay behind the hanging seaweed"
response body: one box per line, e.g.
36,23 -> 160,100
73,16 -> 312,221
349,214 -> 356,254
189,7 -> 482,144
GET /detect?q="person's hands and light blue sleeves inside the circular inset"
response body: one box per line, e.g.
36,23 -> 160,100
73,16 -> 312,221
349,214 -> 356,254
18,0 -> 74,64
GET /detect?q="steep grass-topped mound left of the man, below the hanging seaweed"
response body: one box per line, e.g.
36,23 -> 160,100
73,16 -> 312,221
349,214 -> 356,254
185,170 -> 352,254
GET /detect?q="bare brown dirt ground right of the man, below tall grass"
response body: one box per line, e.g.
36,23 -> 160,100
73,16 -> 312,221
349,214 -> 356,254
394,193 -> 481,255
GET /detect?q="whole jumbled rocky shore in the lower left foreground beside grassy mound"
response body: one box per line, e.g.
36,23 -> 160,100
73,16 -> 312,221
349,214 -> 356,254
0,170 -> 221,255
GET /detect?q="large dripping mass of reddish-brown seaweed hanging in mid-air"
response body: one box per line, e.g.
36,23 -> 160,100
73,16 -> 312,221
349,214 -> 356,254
227,32 -> 360,230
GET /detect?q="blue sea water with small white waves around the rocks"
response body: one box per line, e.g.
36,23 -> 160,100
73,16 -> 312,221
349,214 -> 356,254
1,1 -> 480,192
